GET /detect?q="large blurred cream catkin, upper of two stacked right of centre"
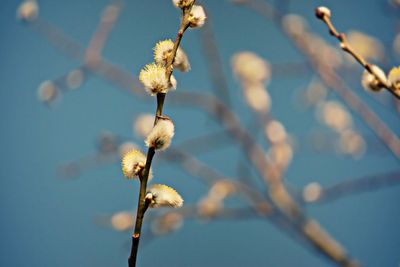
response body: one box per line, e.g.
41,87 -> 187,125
232,51 -> 271,83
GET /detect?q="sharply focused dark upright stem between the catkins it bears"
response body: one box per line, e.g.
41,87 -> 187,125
128,3 -> 194,267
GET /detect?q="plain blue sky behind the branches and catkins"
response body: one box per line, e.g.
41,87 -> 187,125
0,0 -> 400,266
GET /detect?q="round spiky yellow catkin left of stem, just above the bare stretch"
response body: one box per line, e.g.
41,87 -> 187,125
139,63 -> 169,95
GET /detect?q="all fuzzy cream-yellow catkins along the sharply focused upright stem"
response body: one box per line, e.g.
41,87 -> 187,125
122,0 -> 206,208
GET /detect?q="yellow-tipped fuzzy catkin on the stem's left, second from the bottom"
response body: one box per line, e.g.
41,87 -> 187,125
121,150 -> 153,180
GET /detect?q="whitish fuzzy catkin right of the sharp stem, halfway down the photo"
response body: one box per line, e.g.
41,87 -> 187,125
145,117 -> 174,150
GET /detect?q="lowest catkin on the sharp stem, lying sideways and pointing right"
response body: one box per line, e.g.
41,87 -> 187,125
146,184 -> 183,208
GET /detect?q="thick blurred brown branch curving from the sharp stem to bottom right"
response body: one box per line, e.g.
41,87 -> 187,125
171,92 -> 358,267
